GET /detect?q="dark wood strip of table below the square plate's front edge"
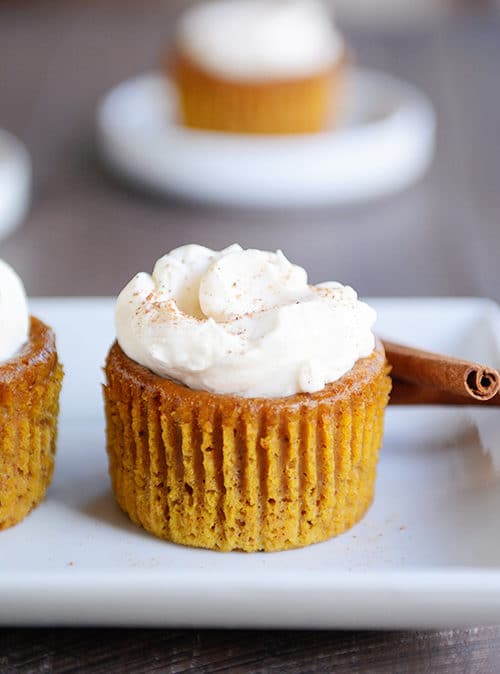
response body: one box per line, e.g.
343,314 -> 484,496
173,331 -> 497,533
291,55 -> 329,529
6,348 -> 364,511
0,627 -> 500,674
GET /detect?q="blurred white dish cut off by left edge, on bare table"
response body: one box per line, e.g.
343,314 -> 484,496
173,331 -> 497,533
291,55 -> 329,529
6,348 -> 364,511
0,129 -> 31,239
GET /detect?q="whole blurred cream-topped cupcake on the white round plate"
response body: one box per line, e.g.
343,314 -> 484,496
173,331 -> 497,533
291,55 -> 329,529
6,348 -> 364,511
170,0 -> 345,134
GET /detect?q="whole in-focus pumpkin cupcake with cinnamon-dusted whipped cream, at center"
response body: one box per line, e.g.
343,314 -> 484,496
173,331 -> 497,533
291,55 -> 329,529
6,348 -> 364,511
104,245 -> 390,551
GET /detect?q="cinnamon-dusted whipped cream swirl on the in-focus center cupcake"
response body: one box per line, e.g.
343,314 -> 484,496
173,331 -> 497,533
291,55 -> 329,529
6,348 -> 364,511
116,244 -> 375,398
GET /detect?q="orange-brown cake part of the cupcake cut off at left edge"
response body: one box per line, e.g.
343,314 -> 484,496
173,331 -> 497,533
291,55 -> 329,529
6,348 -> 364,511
0,317 -> 63,529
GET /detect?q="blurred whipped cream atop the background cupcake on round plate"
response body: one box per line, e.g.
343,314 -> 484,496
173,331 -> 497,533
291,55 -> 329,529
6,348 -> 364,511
177,0 -> 343,80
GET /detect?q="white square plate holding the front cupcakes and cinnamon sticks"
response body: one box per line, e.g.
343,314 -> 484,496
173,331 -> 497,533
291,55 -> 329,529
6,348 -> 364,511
0,298 -> 500,628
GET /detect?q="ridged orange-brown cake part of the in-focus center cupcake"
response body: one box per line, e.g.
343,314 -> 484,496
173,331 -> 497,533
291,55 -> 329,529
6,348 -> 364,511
104,343 -> 390,551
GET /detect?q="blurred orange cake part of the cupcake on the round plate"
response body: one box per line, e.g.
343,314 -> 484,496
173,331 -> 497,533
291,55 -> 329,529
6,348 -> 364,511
166,53 -> 345,134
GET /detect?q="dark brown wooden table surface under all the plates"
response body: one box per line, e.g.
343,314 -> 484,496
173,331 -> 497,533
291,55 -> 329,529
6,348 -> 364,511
0,0 -> 500,674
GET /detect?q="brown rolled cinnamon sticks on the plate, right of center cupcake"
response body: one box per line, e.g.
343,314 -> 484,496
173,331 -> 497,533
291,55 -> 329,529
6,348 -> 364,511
383,340 -> 500,405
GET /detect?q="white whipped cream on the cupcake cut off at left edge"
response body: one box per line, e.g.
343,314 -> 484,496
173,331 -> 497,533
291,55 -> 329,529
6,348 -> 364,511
0,260 -> 29,362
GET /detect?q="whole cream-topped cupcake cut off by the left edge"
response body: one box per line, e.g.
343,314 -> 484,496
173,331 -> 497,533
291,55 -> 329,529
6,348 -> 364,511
0,260 -> 63,529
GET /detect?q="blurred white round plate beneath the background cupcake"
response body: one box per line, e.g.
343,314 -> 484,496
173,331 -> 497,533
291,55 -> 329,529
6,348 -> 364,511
97,69 -> 435,207
